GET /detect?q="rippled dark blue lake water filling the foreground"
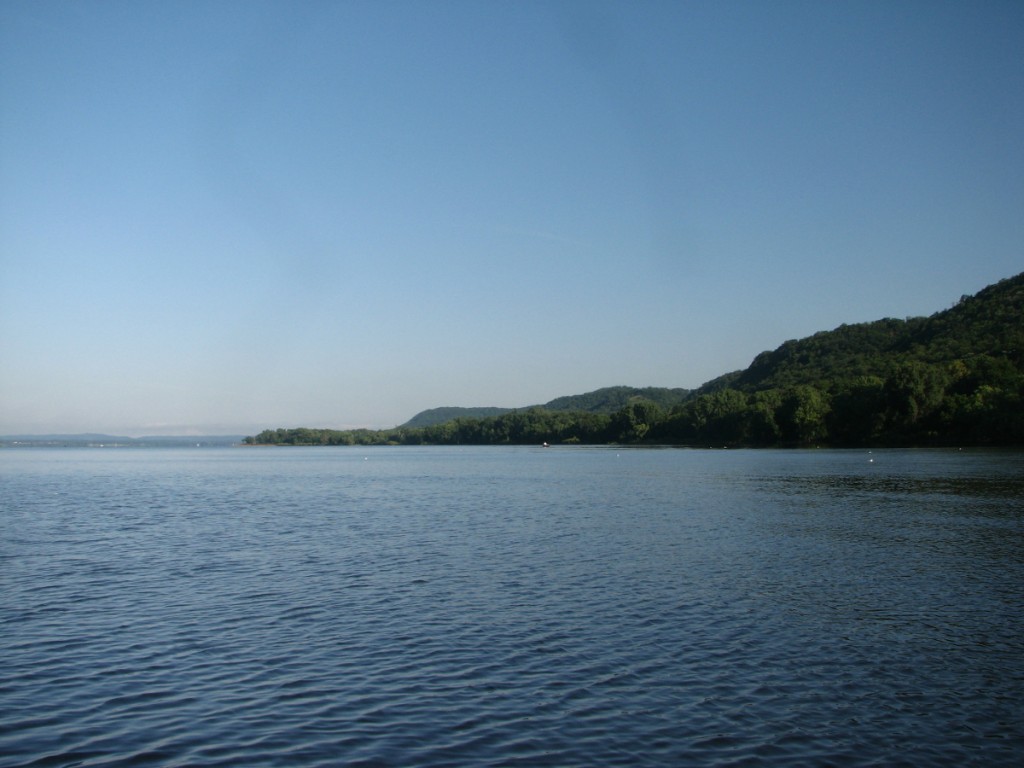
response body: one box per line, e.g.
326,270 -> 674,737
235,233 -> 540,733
0,447 -> 1024,767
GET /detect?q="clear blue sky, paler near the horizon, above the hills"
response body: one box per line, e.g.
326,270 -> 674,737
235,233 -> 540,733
0,0 -> 1024,434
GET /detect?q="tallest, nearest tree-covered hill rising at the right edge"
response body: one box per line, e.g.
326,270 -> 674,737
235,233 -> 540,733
657,273 -> 1024,445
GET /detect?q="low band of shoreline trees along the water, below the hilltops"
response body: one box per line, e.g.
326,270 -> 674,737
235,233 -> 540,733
246,355 -> 1024,447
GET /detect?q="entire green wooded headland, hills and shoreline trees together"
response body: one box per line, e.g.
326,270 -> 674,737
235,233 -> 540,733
246,273 -> 1024,446
